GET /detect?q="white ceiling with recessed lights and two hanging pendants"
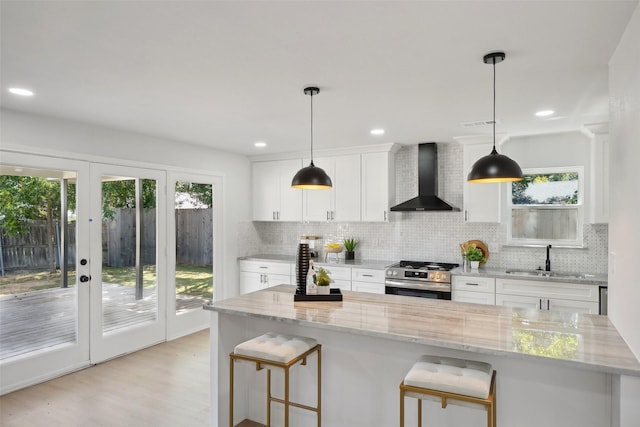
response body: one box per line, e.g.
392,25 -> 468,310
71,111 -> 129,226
1,0 -> 638,155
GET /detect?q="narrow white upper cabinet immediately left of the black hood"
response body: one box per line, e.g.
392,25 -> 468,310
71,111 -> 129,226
362,151 -> 395,221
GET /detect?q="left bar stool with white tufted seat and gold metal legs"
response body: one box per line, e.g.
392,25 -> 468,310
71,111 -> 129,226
229,332 -> 322,427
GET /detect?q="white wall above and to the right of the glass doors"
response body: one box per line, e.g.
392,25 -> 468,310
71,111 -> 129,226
0,109 -> 251,296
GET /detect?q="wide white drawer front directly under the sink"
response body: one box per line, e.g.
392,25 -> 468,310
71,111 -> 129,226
496,278 -> 600,302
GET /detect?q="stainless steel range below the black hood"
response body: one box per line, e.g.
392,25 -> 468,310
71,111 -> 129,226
384,261 -> 459,300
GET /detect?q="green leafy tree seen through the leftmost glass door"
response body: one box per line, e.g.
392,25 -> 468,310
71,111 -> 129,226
0,175 -> 60,273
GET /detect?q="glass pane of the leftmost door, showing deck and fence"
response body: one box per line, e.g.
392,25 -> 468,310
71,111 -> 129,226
0,166 -> 78,360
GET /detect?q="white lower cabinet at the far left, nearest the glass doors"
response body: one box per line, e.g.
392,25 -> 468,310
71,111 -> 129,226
239,261 -> 295,294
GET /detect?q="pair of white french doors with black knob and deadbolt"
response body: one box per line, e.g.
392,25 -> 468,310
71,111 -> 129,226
0,151 -> 175,394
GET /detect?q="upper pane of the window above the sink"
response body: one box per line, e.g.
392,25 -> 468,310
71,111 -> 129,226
511,172 -> 578,205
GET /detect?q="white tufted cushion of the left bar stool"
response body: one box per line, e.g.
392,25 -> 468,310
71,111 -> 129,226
233,332 -> 316,363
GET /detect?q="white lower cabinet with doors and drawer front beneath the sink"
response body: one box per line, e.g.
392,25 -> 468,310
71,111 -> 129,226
496,278 -> 600,314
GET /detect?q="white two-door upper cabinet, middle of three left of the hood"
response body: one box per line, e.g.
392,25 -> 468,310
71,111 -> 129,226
302,154 -> 361,221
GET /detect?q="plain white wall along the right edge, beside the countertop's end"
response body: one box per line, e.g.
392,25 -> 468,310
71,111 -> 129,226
609,6 -> 640,426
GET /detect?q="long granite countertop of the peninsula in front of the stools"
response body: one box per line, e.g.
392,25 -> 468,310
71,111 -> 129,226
204,285 -> 640,377
